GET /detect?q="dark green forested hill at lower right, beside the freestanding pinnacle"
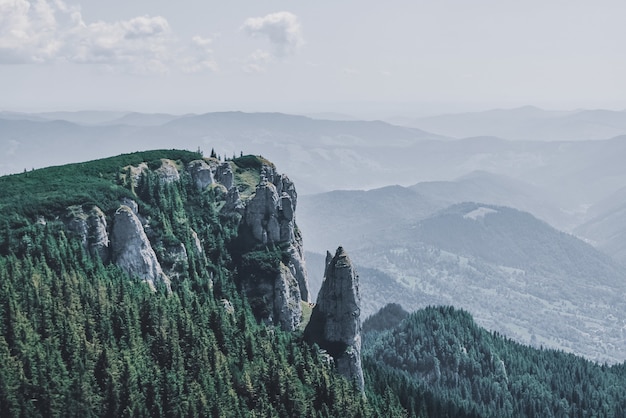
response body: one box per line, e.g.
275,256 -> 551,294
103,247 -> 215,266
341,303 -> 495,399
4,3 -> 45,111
364,307 -> 626,417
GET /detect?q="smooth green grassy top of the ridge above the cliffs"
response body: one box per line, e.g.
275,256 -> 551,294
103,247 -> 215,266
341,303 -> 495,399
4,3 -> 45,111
0,149 -> 274,228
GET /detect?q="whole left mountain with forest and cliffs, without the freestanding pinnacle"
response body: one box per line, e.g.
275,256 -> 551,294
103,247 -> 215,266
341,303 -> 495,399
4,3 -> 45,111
0,150 -> 404,417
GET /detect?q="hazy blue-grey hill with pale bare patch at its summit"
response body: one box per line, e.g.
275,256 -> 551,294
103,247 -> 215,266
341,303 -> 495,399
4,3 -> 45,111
346,203 -> 626,362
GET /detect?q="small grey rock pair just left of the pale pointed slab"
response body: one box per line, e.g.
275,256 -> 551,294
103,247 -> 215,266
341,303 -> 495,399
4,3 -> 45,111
65,205 -> 109,263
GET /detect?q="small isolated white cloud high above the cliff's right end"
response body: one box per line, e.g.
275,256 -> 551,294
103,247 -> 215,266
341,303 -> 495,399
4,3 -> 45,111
242,12 -> 304,57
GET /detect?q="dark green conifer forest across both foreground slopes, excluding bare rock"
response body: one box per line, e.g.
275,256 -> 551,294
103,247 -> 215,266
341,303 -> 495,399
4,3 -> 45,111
0,150 -> 626,418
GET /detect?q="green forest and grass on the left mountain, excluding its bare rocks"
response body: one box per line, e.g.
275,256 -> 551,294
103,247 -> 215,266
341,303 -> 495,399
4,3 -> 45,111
0,151 -> 426,417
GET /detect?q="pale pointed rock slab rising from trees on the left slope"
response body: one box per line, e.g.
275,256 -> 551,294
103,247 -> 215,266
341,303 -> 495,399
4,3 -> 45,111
111,205 -> 171,290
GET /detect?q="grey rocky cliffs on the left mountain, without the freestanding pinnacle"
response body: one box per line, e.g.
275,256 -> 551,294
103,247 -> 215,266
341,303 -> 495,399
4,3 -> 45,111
59,156 -> 309,330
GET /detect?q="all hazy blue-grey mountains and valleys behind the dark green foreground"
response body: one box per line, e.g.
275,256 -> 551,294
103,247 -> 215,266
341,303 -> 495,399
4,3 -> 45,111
0,108 -> 626,361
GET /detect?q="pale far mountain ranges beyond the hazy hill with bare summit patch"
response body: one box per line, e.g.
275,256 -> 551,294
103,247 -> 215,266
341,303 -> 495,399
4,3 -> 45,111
6,107 -> 626,288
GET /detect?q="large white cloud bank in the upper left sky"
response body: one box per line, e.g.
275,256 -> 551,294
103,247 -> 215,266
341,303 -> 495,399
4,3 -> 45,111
0,0 -> 217,74
